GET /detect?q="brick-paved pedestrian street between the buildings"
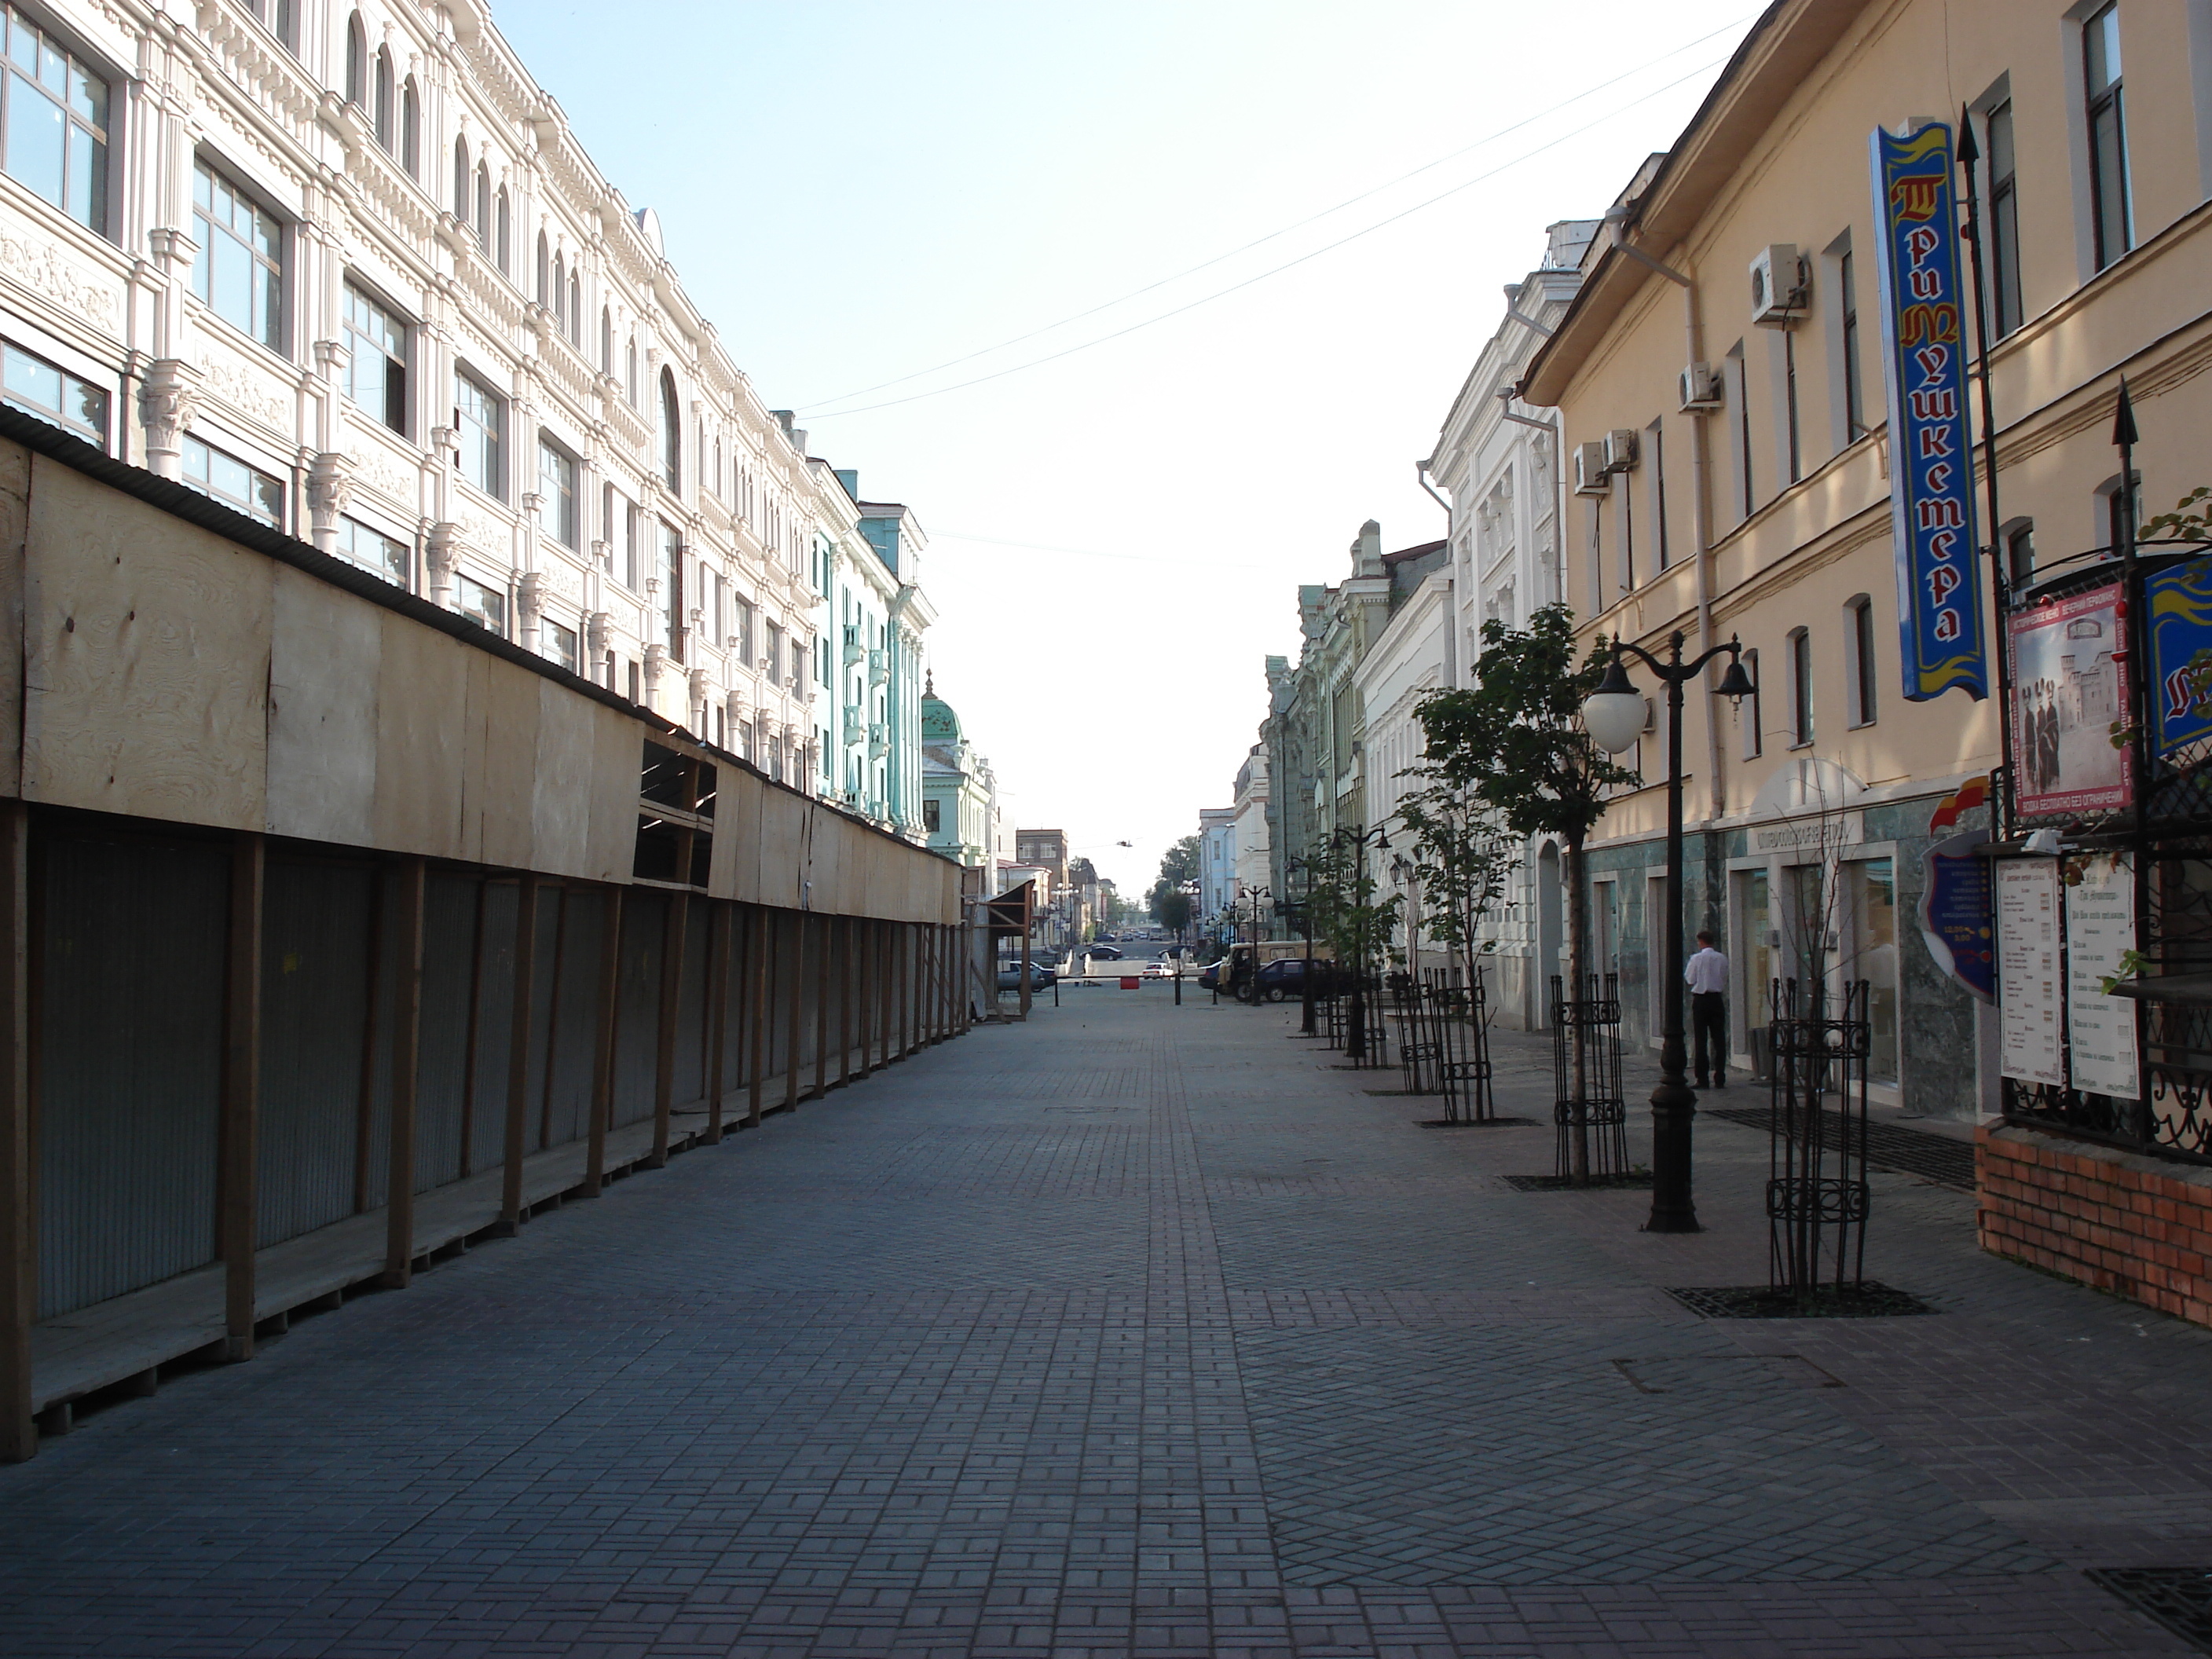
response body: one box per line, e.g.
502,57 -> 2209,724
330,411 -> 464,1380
0,987 -> 2212,1659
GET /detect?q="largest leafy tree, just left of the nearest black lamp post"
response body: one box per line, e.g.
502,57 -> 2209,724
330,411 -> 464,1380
1415,604 -> 1639,1179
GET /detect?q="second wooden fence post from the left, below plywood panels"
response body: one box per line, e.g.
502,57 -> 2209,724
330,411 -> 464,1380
214,832 -> 268,1361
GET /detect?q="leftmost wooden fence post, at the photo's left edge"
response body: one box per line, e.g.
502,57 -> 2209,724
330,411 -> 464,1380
0,800 -> 38,1462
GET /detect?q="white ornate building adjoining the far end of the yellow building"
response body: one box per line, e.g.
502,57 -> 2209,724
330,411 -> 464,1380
1423,219 -> 1597,1027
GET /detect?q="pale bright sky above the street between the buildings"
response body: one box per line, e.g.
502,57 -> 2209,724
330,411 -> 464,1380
493,0 -> 1759,895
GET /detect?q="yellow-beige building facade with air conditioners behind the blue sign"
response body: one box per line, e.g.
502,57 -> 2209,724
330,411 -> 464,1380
1522,0 -> 2212,1117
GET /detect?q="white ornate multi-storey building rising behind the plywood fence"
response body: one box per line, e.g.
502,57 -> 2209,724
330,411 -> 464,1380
0,0 -> 929,805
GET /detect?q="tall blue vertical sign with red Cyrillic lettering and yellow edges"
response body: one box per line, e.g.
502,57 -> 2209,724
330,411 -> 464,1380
1871,122 -> 1989,703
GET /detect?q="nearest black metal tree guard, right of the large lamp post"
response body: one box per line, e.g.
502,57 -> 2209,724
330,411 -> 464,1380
1767,980 -> 1873,1307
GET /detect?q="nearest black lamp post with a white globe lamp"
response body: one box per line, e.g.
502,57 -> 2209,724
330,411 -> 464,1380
1575,631 -> 1752,1232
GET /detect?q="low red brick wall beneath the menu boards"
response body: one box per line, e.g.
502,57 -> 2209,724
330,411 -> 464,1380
1973,1124 -> 2212,1325
